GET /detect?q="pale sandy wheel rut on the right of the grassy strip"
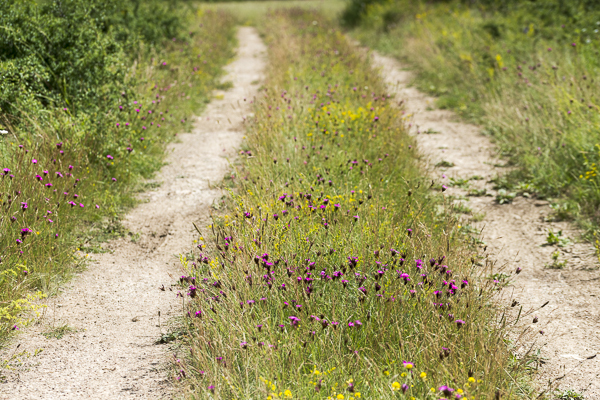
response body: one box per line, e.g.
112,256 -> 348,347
371,52 -> 600,399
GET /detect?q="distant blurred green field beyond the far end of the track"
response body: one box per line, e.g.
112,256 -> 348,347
202,0 -> 346,24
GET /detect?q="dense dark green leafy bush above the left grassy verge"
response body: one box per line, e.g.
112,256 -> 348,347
0,0 -> 182,117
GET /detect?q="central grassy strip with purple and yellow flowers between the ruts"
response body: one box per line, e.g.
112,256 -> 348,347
174,9 -> 528,399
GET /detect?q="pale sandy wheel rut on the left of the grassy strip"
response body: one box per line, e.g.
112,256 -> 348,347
0,27 -> 266,400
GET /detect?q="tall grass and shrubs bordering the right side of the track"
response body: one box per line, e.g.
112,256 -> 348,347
344,0 -> 600,244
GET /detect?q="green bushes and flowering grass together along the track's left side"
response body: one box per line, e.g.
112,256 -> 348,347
0,0 -> 234,345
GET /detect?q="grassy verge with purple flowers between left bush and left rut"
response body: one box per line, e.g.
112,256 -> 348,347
0,7 -> 235,344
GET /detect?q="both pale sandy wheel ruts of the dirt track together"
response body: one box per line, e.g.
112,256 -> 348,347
0,21 -> 600,399
